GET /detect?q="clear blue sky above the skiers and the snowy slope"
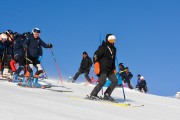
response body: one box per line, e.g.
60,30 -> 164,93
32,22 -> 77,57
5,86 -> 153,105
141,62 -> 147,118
0,0 -> 180,96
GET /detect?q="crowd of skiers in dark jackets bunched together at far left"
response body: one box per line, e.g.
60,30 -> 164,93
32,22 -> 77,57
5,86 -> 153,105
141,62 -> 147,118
0,28 -> 53,88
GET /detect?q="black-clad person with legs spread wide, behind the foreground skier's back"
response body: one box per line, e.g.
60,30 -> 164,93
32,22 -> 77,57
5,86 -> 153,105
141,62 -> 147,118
72,52 -> 92,82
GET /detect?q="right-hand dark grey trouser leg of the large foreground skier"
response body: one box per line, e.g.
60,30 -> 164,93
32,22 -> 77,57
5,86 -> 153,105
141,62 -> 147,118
104,73 -> 118,96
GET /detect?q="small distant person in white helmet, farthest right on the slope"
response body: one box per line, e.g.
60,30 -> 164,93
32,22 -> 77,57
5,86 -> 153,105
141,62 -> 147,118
136,76 -> 148,93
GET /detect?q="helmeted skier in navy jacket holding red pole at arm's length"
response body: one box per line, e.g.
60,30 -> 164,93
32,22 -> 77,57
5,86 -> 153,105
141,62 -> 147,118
23,28 -> 53,87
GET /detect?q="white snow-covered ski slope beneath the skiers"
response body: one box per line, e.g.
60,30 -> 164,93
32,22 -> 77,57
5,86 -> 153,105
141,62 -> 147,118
0,80 -> 180,120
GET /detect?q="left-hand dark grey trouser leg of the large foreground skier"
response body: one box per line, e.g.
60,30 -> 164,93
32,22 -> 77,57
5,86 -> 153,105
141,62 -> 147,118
91,73 -> 107,96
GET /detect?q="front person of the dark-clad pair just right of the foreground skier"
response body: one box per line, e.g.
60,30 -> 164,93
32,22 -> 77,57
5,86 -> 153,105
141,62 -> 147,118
122,67 -> 133,89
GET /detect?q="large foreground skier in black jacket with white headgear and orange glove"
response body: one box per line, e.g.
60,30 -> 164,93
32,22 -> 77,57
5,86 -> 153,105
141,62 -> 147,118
90,34 -> 118,101
